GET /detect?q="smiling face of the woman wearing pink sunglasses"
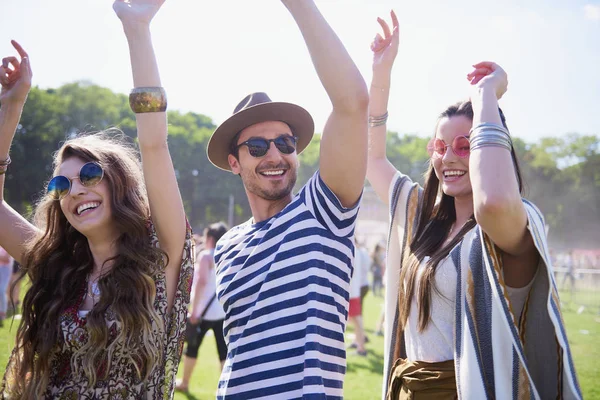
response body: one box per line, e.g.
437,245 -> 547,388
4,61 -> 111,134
432,115 -> 473,198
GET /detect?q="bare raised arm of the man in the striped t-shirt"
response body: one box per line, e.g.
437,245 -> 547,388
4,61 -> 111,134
282,0 -> 369,207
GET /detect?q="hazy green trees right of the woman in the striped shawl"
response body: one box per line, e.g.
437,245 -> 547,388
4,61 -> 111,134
515,133 -> 600,249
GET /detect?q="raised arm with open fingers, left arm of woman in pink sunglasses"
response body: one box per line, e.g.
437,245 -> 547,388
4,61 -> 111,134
367,11 -> 400,204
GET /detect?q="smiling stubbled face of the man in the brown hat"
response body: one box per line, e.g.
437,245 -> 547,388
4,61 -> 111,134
228,121 -> 298,201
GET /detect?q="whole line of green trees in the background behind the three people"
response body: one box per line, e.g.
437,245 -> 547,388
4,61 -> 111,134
5,82 -> 600,244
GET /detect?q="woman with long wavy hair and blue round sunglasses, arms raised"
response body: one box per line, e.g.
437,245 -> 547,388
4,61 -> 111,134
0,0 -> 193,399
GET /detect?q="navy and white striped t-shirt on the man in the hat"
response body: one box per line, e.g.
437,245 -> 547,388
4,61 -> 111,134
215,172 -> 358,400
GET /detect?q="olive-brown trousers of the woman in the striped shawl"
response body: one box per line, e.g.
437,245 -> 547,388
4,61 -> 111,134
386,359 -> 458,400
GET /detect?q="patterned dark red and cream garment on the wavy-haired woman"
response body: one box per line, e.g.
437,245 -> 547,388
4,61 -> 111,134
0,223 -> 194,400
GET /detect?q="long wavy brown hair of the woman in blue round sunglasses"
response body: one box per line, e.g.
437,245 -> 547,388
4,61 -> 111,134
6,131 -> 167,399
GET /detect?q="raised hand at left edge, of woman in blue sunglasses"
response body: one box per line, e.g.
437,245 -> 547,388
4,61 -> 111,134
0,40 -> 32,104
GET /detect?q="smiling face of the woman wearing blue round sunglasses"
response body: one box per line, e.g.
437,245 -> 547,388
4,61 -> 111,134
55,157 -> 114,237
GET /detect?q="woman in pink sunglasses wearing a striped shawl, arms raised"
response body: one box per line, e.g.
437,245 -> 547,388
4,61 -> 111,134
367,13 -> 581,399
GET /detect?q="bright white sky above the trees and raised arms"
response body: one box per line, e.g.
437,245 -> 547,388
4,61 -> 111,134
0,0 -> 600,141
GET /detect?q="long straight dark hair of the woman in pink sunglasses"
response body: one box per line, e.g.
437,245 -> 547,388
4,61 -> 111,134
399,101 -> 523,331
